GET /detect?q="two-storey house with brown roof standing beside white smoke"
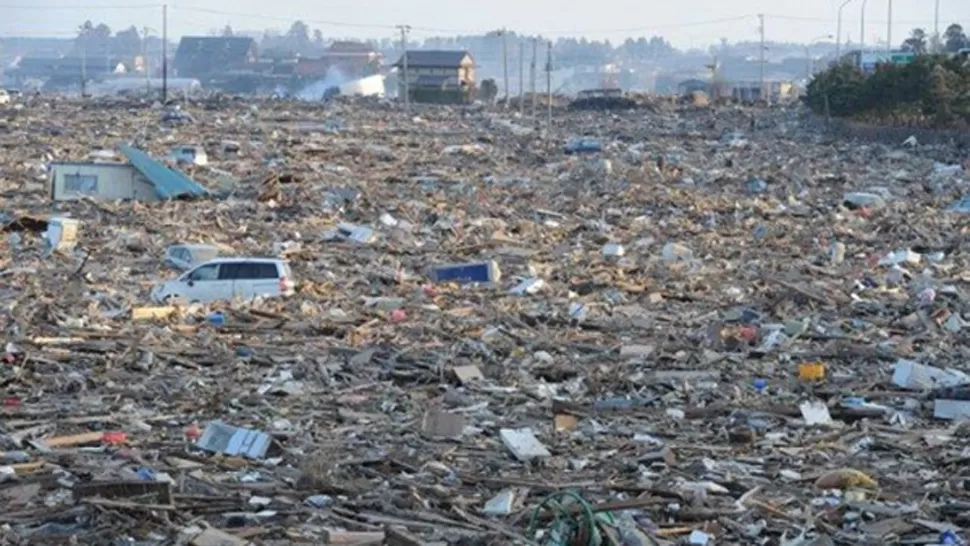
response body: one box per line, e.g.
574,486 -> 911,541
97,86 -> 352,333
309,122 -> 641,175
394,50 -> 476,104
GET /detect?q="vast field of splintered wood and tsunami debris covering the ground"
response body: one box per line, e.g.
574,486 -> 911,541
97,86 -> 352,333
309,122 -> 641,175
0,98 -> 970,546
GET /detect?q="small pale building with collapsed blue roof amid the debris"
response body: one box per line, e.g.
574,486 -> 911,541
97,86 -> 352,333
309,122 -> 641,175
50,146 -> 208,201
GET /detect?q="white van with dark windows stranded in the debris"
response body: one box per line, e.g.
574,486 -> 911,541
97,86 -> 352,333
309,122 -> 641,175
151,258 -> 294,303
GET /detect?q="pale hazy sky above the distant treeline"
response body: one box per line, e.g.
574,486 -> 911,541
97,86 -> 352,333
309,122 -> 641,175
0,0 -> 970,47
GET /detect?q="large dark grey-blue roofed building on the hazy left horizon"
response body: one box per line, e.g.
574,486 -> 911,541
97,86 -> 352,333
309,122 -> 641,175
172,36 -> 259,79
